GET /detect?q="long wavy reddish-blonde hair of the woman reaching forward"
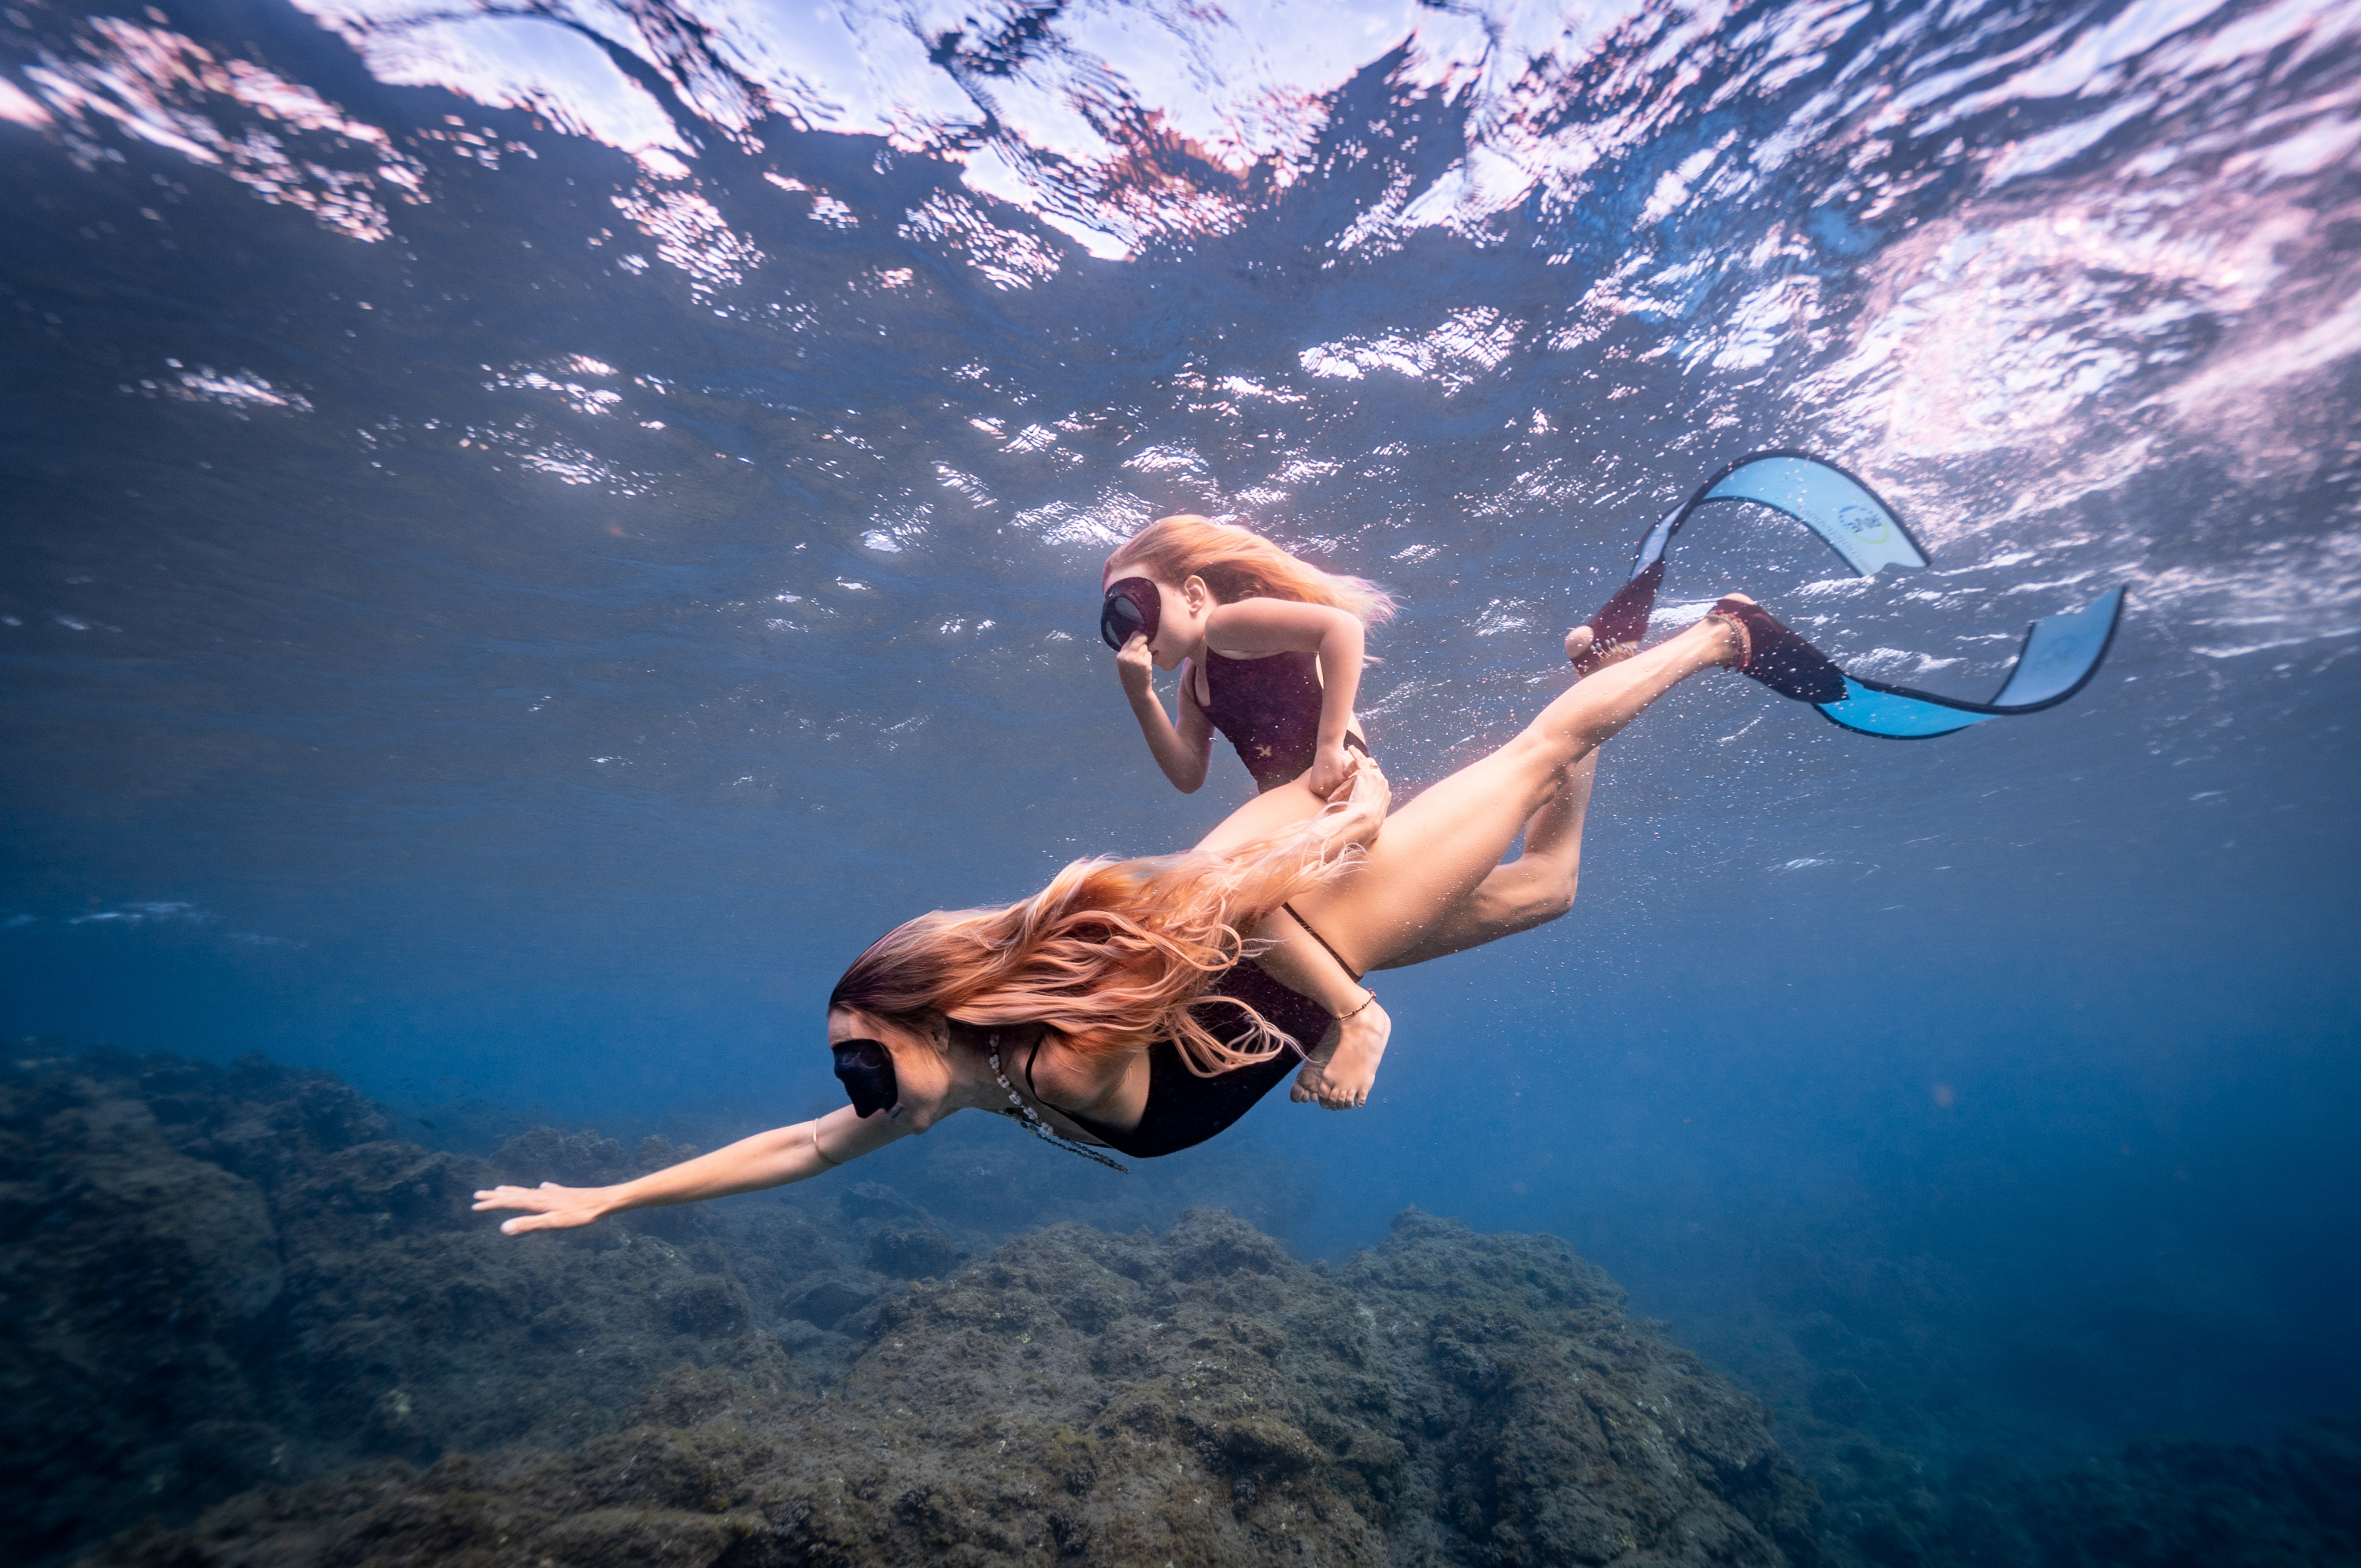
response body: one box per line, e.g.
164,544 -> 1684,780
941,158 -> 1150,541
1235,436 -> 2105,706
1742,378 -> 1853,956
829,817 -> 1360,1077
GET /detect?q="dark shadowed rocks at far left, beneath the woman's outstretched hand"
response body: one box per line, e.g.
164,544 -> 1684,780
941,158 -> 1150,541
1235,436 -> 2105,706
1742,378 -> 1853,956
0,1053 -> 864,1561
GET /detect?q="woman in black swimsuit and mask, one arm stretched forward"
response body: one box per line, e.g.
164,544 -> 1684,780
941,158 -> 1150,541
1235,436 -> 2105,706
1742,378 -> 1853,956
475,595 -> 1842,1235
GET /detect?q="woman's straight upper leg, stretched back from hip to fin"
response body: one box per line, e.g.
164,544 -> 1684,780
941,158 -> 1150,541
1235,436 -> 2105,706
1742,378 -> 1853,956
1296,621 -> 1738,971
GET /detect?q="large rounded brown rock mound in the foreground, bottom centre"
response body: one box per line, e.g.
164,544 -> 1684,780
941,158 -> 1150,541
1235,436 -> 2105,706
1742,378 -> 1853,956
94,1209 -> 1811,1568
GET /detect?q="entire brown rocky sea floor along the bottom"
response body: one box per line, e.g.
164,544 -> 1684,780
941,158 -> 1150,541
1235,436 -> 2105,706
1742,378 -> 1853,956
0,1044 -> 2361,1568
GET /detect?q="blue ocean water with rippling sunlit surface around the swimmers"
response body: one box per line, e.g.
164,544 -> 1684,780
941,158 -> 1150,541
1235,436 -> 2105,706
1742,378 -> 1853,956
0,0 -> 2361,1529
